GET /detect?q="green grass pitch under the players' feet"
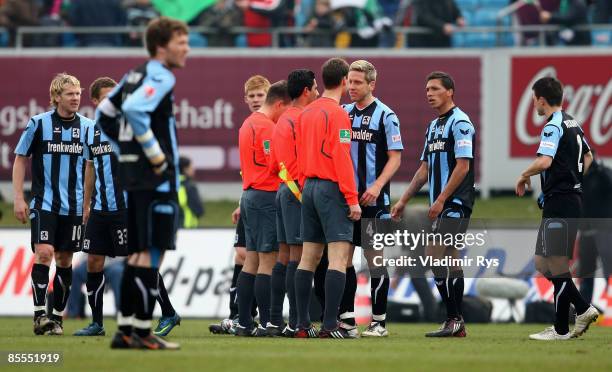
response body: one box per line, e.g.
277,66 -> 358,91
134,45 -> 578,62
0,318 -> 612,372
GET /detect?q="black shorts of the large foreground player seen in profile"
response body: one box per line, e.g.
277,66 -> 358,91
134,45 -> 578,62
127,190 -> 179,254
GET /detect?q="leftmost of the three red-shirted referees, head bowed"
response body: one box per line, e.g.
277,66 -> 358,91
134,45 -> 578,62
235,80 -> 291,337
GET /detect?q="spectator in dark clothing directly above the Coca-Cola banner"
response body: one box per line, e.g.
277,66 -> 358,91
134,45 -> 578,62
540,0 -> 591,45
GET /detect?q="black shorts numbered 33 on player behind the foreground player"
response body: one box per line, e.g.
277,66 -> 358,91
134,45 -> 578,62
83,210 -> 128,257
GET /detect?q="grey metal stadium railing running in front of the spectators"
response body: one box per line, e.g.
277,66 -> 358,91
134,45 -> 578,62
13,24 -> 612,49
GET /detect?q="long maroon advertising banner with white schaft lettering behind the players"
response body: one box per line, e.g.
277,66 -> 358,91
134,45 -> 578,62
0,56 -> 481,182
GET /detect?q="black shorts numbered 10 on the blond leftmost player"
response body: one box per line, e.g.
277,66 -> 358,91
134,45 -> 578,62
30,209 -> 83,252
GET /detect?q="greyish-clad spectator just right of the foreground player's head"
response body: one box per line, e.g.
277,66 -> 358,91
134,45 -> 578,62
198,0 -> 243,47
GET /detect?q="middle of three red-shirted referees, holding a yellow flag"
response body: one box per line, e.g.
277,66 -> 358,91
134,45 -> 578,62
266,69 -> 319,337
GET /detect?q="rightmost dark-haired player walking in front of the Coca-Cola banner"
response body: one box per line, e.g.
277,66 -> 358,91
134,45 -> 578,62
516,77 -> 599,341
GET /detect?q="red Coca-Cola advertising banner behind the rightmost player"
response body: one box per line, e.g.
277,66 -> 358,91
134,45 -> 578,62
510,55 -> 612,157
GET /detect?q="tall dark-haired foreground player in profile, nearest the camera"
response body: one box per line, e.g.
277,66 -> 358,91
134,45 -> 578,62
97,17 -> 189,350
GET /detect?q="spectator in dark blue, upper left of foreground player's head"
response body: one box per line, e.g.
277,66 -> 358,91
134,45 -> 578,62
70,0 -> 126,47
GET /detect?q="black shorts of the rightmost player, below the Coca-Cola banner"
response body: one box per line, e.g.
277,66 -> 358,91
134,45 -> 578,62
535,194 -> 582,257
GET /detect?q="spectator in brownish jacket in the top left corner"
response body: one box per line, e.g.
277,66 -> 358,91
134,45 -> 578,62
0,0 -> 42,46
